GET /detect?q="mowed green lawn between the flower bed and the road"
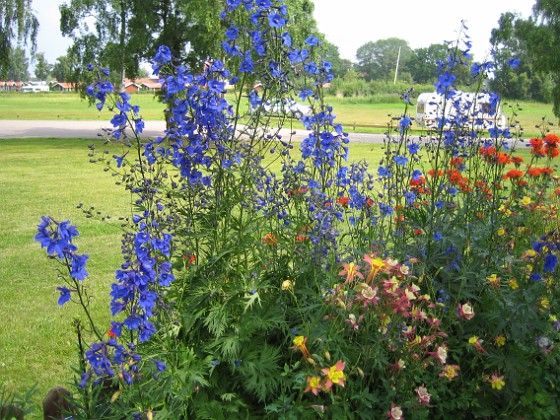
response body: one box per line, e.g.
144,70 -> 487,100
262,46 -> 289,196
0,135 -> 383,418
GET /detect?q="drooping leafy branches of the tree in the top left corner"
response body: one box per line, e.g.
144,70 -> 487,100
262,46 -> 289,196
0,0 -> 39,77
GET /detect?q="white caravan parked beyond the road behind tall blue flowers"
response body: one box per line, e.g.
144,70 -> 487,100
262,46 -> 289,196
416,91 -> 507,130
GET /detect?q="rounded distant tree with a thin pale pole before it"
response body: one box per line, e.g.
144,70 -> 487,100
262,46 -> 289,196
356,38 -> 412,80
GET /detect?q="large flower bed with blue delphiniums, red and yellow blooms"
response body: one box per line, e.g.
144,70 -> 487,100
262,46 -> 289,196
37,0 -> 560,418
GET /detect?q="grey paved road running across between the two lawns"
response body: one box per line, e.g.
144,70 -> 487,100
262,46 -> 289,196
0,120 -> 384,143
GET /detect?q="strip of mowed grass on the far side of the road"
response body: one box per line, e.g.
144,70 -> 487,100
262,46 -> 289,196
0,92 -> 559,136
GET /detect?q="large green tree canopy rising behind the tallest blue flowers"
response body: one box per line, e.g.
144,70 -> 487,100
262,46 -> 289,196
60,0 -> 316,81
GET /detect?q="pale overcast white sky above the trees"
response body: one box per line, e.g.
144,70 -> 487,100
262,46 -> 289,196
33,0 -> 535,64
